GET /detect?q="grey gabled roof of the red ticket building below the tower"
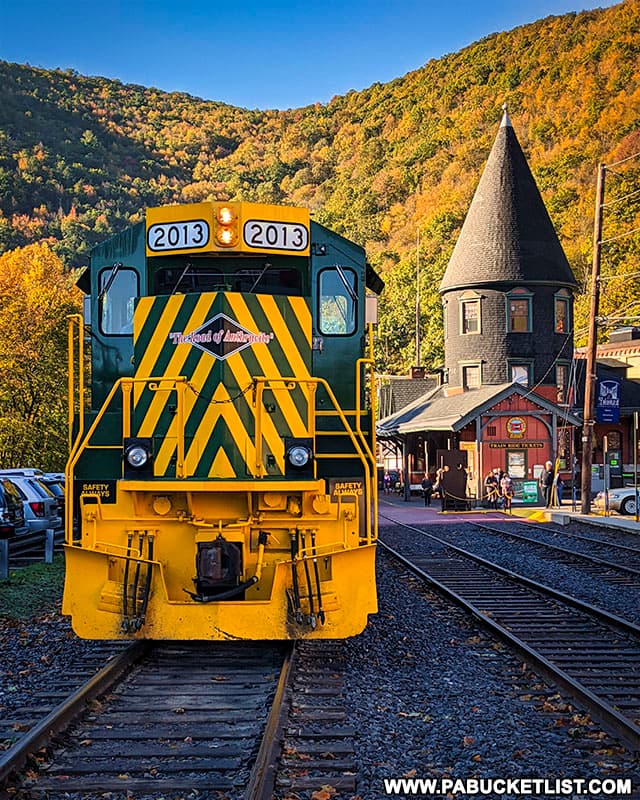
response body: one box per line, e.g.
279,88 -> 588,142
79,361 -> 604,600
376,383 -> 581,439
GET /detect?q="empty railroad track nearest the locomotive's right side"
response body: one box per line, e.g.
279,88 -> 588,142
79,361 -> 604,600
380,517 -> 640,751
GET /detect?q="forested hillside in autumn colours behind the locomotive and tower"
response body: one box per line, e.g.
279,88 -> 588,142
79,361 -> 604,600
0,0 -> 640,371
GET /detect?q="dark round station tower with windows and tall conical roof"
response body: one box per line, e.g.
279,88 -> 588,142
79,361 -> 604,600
440,108 -> 577,402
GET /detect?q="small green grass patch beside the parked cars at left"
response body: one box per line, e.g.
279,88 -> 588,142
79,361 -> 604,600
0,554 -> 64,619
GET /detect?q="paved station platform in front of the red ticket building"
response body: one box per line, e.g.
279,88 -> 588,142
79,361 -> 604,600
378,492 -> 640,537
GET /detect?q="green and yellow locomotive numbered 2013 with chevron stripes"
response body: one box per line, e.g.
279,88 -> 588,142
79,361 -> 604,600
63,202 -> 382,639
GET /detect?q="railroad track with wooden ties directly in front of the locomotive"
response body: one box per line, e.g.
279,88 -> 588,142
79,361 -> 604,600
0,642 -> 355,800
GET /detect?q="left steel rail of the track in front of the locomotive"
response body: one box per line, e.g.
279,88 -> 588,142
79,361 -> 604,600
0,641 -> 150,787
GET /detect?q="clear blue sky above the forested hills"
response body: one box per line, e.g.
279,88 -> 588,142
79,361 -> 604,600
0,0 -> 611,109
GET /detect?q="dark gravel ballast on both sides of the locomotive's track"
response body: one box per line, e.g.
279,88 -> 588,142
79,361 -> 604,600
0,548 -> 640,800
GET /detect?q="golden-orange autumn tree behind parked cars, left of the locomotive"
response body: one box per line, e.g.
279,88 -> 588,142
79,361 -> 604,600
0,244 -> 81,470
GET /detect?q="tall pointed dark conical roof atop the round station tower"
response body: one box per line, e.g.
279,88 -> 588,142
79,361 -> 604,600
440,111 -> 577,292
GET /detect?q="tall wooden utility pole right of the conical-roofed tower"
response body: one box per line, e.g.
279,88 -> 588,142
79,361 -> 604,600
580,164 -> 606,514
